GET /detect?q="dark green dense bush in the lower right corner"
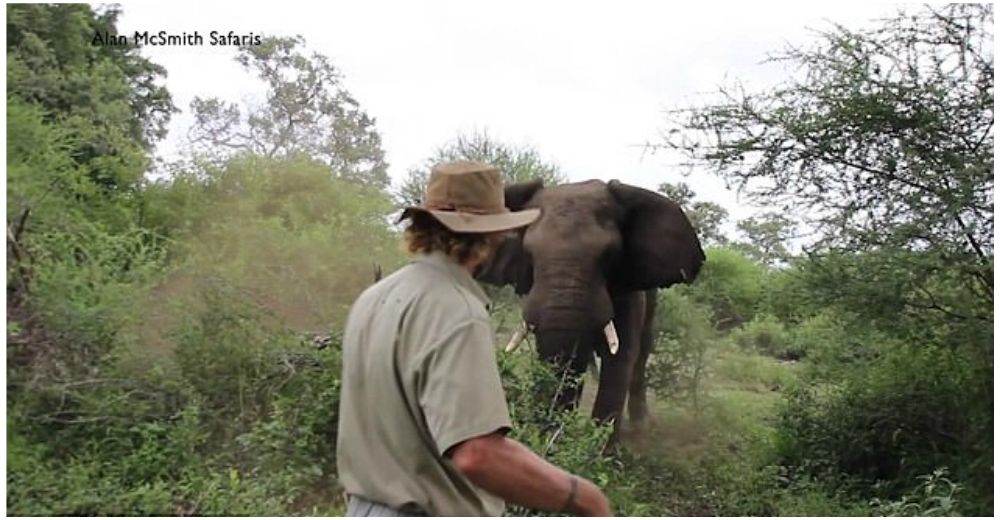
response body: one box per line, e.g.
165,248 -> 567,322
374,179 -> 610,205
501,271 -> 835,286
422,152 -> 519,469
777,347 -> 993,514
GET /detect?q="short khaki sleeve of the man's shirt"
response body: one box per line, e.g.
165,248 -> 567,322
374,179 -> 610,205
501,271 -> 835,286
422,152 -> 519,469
418,319 -> 511,455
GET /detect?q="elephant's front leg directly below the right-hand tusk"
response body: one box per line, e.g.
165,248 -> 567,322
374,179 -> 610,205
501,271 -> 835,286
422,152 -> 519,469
593,292 -> 645,434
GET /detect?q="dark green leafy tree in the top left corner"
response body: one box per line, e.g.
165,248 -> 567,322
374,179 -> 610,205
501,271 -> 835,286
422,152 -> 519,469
7,4 -> 176,194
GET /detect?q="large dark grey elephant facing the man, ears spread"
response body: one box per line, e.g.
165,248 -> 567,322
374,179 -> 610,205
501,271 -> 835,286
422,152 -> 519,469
477,181 -> 705,433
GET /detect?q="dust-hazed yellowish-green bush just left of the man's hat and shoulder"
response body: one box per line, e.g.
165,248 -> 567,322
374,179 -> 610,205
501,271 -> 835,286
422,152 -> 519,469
148,156 -> 406,331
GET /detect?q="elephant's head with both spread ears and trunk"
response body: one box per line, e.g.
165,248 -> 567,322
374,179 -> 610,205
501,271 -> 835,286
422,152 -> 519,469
477,181 -> 705,360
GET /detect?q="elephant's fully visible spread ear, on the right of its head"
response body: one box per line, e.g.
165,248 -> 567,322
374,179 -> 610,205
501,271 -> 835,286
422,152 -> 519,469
608,181 -> 705,290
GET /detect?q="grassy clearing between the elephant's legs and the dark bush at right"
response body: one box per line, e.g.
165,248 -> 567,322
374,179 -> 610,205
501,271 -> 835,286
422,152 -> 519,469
501,335 -> 872,516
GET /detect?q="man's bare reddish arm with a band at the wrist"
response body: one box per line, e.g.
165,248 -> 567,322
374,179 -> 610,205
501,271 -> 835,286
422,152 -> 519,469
447,433 -> 612,516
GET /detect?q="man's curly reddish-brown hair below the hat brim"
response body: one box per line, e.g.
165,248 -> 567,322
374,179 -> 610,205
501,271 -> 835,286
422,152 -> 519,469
404,212 -> 504,264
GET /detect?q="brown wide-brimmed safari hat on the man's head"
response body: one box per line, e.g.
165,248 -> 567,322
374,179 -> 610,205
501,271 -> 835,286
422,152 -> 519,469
399,161 -> 541,233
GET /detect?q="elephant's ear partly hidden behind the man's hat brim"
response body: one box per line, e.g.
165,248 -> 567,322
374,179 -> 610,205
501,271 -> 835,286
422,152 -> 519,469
476,180 -> 543,294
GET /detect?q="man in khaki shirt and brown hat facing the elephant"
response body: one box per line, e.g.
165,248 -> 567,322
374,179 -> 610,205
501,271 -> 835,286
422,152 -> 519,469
337,161 -> 611,516
